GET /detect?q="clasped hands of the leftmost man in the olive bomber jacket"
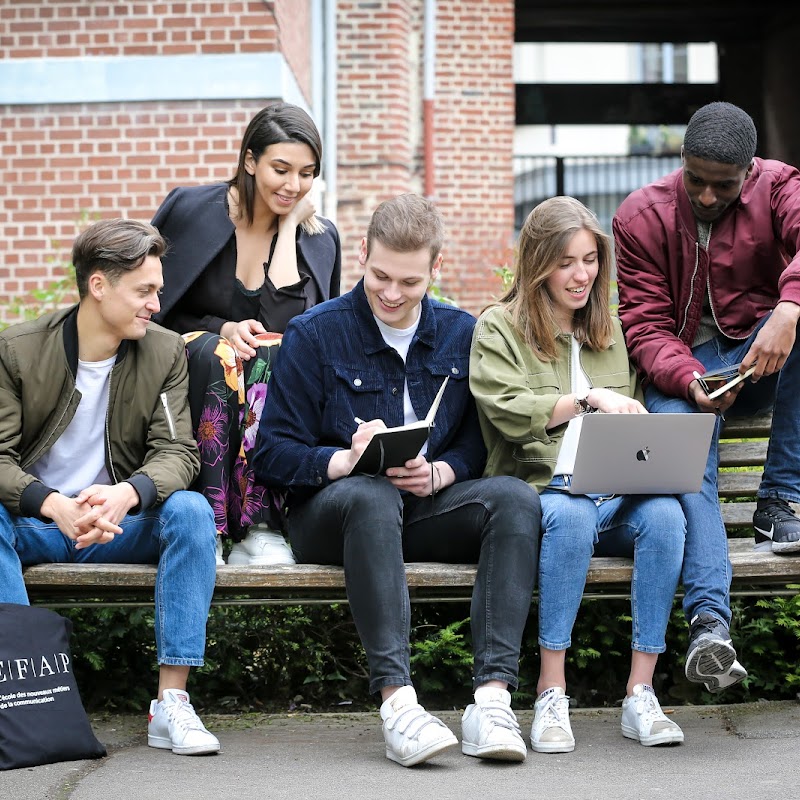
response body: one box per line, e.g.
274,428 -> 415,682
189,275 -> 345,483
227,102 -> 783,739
41,481 -> 139,550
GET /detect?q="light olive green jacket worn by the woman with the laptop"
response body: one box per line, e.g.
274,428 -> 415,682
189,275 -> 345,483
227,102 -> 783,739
469,306 -> 642,491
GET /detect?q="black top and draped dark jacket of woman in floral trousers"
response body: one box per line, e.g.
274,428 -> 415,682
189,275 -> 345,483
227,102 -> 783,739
153,183 -> 341,333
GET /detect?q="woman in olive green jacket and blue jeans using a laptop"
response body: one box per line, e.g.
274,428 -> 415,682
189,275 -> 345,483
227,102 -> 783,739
470,197 -> 686,753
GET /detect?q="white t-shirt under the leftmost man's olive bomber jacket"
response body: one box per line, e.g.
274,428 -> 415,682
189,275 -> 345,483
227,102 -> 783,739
28,356 -> 117,497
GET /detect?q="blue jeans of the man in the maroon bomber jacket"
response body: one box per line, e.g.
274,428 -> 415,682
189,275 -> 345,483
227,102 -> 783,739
645,317 -> 800,625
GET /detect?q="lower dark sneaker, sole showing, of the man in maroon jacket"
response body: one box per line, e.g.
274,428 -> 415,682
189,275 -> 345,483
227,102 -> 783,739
684,611 -> 747,692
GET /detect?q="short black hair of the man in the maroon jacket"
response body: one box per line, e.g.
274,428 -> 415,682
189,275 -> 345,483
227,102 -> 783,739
683,102 -> 758,167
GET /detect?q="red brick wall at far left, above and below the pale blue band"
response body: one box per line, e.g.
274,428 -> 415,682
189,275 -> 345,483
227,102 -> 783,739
0,0 -> 311,320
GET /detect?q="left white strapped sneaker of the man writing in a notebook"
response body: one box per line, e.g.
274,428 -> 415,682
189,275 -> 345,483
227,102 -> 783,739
381,686 -> 458,767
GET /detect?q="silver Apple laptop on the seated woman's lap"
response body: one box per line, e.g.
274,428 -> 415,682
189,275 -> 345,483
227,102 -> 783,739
569,413 -> 716,494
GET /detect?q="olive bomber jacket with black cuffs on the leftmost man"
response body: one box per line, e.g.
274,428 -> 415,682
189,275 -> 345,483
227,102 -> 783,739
0,306 -> 200,518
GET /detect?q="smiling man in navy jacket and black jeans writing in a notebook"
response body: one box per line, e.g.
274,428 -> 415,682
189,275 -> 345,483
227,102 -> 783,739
254,194 -> 540,766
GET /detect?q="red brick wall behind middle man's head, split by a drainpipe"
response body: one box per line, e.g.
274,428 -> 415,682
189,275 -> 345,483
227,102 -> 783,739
337,0 -> 514,312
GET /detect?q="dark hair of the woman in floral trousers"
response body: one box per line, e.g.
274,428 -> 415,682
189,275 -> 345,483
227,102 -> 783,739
228,103 -> 322,225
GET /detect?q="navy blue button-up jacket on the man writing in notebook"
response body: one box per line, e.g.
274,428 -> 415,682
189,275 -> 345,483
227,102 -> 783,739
253,280 -> 486,503
